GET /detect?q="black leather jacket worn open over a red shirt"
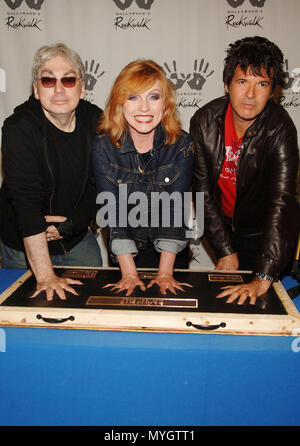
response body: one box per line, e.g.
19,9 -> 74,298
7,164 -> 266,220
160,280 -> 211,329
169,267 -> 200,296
190,96 -> 300,278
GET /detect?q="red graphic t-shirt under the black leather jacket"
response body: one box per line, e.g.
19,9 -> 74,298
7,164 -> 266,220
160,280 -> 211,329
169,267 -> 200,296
218,104 -> 243,218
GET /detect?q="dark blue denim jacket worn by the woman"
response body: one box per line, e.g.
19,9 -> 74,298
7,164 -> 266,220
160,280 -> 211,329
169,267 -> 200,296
92,126 -> 194,254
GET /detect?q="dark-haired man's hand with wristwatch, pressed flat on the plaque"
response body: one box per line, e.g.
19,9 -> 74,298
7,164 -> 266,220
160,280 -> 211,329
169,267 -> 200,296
216,273 -> 273,305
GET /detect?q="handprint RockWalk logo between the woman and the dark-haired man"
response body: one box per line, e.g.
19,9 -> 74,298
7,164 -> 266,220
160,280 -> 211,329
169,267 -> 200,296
162,58 -> 214,108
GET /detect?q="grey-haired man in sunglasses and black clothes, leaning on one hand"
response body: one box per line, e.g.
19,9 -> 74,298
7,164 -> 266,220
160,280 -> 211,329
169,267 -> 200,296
0,43 -> 102,300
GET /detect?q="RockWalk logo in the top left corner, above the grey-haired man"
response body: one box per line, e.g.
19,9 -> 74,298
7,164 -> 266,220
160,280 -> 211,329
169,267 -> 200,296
2,0 -> 44,31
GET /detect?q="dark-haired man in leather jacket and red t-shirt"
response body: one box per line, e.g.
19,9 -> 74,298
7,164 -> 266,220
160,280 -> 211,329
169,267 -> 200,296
190,37 -> 300,304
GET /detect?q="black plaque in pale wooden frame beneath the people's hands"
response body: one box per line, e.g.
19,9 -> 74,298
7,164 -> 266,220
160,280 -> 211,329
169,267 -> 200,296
1,268 -> 287,315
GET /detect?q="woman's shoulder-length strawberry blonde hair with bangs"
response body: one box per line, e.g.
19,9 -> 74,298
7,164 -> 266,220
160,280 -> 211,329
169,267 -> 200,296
98,59 -> 181,147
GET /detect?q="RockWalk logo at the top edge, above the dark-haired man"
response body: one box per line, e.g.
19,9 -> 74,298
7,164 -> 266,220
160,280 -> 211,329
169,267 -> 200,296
224,0 -> 266,29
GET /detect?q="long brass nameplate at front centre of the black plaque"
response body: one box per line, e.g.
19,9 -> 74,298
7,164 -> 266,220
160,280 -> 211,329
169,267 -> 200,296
86,296 -> 198,308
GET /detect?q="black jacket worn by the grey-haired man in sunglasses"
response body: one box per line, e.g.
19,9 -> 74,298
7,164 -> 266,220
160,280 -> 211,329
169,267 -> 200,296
0,96 -> 101,254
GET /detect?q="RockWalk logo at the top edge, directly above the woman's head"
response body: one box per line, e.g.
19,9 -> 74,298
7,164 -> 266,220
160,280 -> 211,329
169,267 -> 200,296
112,0 -> 154,31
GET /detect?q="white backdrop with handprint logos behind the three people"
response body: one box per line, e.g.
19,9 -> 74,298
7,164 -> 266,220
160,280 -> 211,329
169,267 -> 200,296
0,0 -> 300,266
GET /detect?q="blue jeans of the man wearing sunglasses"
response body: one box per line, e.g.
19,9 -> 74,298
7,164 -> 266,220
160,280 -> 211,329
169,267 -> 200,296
0,231 -> 102,269
